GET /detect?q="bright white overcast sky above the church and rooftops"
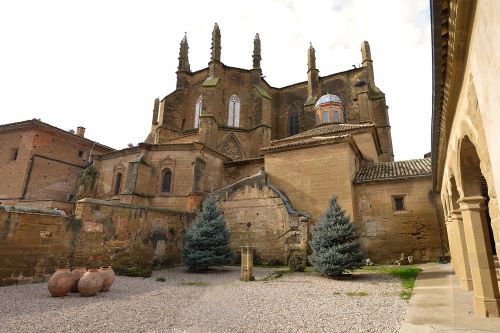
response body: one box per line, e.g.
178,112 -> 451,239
0,0 -> 432,160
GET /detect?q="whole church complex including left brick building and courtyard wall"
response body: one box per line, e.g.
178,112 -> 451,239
0,24 -> 448,284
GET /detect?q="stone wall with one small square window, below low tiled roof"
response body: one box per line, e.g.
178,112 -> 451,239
354,178 -> 446,263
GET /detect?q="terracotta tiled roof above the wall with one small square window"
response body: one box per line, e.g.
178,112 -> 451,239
353,158 -> 432,183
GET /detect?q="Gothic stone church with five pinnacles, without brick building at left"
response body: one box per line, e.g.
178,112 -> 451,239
69,24 -> 443,263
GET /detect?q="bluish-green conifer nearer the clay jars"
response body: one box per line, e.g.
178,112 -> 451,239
182,196 -> 235,270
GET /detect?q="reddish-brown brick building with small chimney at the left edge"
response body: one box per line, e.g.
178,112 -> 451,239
0,119 -> 113,212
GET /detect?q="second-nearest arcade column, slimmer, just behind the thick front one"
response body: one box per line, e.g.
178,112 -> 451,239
451,210 -> 474,290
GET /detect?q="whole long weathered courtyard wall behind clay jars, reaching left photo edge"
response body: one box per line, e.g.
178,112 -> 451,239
0,199 -> 192,285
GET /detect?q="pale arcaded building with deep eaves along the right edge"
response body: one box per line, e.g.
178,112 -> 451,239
431,0 -> 500,317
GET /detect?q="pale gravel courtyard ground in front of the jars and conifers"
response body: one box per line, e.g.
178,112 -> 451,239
0,267 -> 406,333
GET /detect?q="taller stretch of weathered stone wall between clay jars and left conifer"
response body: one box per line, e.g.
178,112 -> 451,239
72,199 -> 191,267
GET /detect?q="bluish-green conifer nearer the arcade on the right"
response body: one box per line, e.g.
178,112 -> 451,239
309,196 -> 365,276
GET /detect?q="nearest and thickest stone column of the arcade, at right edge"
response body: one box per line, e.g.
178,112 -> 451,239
459,196 -> 500,317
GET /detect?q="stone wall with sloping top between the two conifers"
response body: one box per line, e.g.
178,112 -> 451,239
215,172 -> 309,264
